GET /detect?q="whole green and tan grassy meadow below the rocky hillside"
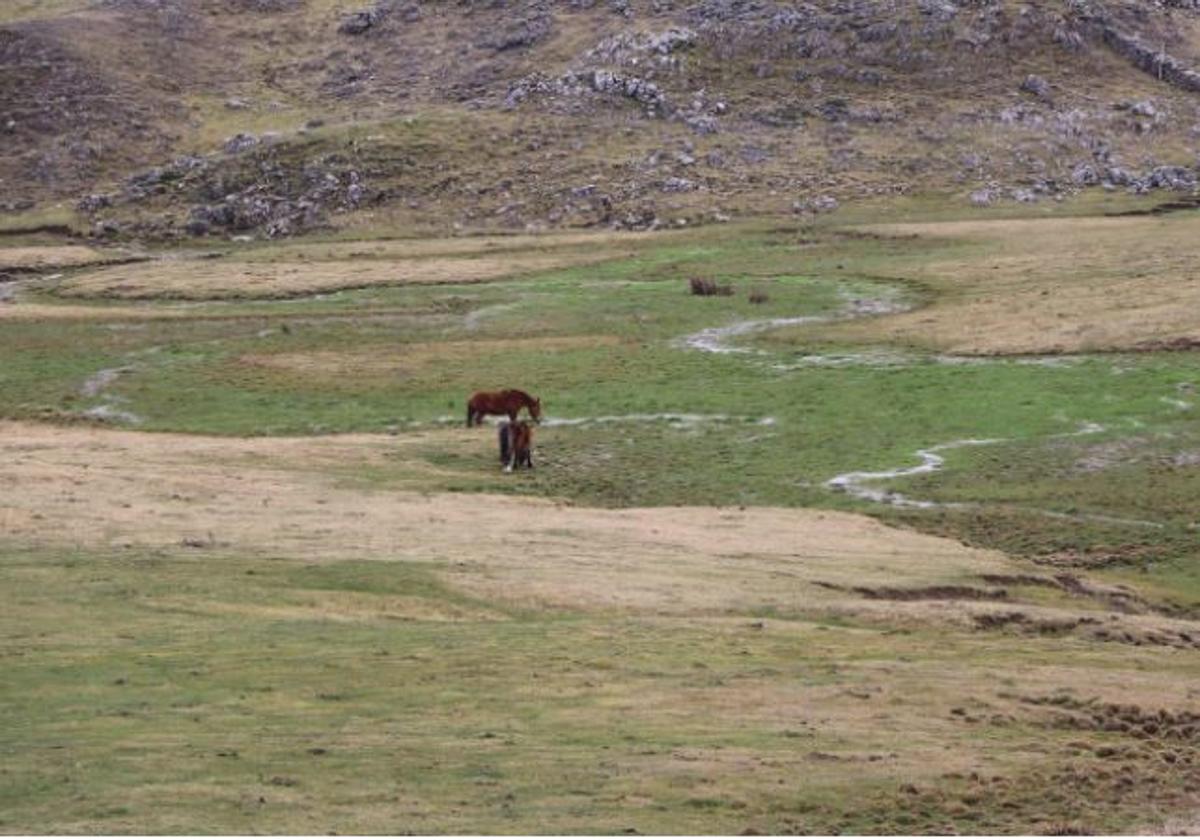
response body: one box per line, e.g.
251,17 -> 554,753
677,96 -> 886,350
0,204 -> 1200,833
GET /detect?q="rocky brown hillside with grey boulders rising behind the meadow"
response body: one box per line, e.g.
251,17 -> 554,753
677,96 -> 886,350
0,0 -> 1200,238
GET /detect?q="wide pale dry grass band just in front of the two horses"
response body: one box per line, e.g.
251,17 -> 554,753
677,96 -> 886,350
0,424 -> 1013,612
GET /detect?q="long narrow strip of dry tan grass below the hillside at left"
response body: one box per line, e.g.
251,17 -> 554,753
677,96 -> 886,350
50,250 -> 620,301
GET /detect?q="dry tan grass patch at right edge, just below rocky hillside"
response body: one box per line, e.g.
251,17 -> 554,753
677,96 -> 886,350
822,214 -> 1200,354
